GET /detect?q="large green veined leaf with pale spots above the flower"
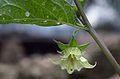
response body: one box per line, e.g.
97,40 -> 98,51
0,0 -> 78,26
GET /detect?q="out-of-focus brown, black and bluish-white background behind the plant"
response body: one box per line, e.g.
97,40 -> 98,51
0,0 -> 120,79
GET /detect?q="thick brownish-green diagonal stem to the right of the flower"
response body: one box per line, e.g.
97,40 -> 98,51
74,0 -> 120,76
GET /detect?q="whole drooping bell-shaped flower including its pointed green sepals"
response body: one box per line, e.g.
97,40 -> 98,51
57,33 -> 95,74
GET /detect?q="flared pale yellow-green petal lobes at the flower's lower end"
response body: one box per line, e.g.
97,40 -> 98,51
58,48 -> 95,74
